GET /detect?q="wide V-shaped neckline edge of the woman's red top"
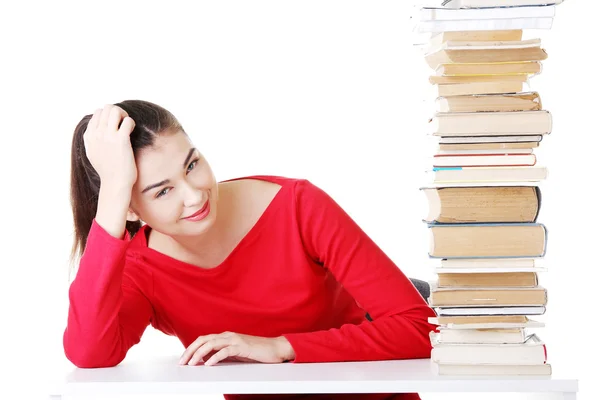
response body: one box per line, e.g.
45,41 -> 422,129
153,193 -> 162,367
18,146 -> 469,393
138,176 -> 290,275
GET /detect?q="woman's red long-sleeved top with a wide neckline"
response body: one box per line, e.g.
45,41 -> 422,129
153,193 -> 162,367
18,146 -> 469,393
63,175 -> 435,400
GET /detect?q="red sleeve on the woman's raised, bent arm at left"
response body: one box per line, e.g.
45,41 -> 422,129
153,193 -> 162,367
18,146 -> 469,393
63,220 -> 153,368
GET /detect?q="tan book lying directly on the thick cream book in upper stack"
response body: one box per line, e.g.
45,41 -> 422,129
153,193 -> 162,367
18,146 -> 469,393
435,92 -> 542,112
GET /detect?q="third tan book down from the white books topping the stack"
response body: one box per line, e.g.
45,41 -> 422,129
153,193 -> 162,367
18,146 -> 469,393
435,61 -> 542,77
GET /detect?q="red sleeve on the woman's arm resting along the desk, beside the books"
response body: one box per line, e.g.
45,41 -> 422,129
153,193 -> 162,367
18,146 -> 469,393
284,180 -> 435,362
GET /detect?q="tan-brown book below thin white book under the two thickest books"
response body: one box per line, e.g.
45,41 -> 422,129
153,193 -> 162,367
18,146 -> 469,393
438,272 -> 538,288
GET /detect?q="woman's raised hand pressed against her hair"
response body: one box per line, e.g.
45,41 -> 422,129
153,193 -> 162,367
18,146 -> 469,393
83,104 -> 137,190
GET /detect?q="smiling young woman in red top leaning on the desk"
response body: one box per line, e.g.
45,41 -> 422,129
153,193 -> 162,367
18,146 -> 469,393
63,100 -> 435,399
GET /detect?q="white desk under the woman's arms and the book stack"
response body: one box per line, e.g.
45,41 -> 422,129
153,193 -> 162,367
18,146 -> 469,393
50,357 -> 578,400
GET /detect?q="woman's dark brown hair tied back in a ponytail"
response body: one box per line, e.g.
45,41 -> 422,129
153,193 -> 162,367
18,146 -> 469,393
70,100 -> 185,263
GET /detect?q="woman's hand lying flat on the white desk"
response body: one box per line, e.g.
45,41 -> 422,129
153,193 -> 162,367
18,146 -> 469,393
179,332 -> 296,365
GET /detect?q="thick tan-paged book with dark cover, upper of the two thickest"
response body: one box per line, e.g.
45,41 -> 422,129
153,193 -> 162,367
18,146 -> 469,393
421,186 -> 541,224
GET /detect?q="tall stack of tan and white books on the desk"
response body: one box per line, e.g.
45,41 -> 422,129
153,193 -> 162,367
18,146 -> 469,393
417,0 -> 557,375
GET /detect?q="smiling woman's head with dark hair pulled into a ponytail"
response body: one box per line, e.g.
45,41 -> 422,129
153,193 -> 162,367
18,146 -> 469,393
71,100 -> 218,260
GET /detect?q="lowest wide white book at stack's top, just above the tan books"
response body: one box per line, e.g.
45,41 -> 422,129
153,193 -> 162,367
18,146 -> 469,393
415,17 -> 554,33
